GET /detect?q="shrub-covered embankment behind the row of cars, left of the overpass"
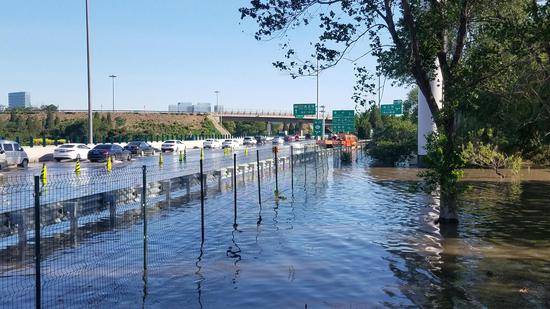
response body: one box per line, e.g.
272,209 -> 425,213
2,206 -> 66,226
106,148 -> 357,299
0,105 -> 224,145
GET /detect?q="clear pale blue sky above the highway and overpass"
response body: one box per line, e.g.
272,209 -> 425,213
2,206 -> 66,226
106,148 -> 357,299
0,0 -> 406,110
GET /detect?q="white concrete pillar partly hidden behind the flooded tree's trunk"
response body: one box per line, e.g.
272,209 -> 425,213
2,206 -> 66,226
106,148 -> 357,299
418,59 -> 443,164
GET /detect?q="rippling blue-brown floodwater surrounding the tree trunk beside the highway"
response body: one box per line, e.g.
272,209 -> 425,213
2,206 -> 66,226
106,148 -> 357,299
1,154 -> 550,308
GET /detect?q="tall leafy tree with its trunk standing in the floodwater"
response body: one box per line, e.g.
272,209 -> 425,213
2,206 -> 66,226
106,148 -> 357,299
240,0 -> 550,223
